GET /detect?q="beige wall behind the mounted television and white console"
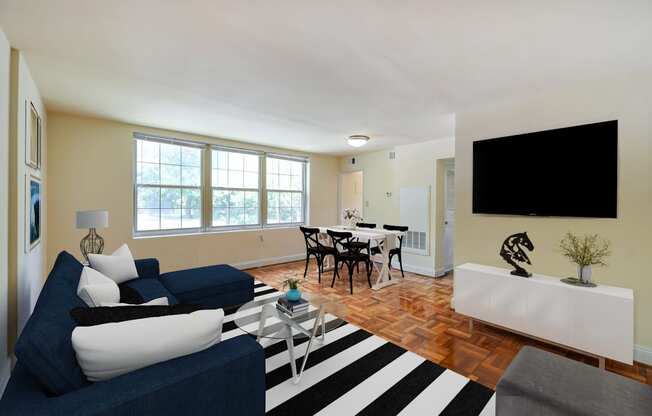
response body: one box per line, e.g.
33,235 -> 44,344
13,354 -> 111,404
455,75 -> 652,360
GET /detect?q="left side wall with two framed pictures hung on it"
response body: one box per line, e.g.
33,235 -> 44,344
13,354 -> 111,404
9,49 -> 48,350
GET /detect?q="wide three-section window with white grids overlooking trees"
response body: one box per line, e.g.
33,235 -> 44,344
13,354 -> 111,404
134,133 -> 308,235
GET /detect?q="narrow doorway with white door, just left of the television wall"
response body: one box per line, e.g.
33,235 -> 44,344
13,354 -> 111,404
435,158 -> 455,276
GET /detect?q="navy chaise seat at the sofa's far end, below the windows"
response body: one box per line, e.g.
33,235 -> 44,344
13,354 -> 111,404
161,264 -> 254,306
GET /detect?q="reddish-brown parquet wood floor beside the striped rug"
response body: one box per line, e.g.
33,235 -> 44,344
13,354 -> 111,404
247,262 -> 652,389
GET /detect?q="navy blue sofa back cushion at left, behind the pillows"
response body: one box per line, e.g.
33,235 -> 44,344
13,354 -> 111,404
15,252 -> 88,395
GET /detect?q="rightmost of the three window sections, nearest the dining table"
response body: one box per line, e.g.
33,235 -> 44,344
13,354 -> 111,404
266,156 -> 306,224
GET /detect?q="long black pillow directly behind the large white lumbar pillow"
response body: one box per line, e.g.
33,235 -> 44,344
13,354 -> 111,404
70,304 -> 203,326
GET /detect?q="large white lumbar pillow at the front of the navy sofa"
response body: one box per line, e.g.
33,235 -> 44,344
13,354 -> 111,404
72,309 -> 224,381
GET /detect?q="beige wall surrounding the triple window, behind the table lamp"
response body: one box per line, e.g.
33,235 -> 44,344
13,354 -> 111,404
48,113 -> 338,271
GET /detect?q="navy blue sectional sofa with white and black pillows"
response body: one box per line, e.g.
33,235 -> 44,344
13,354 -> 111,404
0,252 -> 265,416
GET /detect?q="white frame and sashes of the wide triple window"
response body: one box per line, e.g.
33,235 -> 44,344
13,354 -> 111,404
132,132 -> 310,238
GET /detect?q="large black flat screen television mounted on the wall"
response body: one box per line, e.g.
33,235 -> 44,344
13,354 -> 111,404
473,120 -> 618,218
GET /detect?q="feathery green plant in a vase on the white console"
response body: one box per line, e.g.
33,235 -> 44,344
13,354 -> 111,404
559,232 -> 611,287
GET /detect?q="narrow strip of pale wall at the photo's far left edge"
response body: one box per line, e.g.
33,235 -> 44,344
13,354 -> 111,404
0,29 -> 11,392
